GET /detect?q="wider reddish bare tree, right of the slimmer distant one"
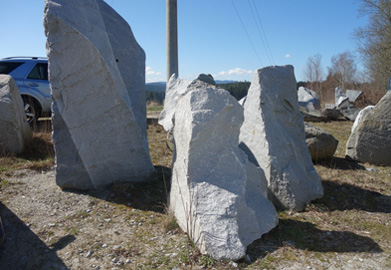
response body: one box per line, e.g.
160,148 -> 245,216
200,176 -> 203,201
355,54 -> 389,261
329,52 -> 357,89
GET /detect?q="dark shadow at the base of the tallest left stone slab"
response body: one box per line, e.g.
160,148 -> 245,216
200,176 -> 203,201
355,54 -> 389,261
64,166 -> 171,213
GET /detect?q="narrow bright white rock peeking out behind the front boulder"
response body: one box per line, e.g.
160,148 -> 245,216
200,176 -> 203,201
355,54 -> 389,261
158,74 -> 190,132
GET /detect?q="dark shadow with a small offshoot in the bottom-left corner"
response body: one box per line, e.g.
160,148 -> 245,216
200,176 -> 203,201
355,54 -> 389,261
0,202 -> 69,269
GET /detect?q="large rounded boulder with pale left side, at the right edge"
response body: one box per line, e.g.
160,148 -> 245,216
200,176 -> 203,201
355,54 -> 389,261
346,91 -> 391,166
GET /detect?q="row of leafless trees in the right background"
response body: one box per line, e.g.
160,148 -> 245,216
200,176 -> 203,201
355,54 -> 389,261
302,0 -> 391,106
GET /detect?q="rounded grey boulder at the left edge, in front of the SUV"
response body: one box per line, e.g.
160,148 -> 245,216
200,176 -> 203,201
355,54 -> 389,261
0,75 -> 32,155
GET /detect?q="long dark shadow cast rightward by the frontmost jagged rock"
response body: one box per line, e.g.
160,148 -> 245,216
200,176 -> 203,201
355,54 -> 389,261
247,219 -> 383,262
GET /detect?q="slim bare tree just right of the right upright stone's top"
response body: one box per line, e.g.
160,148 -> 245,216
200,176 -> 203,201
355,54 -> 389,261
304,53 -> 324,93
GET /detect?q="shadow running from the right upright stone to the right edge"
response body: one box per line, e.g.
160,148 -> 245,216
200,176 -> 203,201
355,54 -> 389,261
312,180 -> 391,213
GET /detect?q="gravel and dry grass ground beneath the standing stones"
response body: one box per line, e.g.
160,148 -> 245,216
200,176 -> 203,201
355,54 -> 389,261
0,117 -> 391,270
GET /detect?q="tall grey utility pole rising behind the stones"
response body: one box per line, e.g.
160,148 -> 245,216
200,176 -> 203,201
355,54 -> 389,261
166,0 -> 179,83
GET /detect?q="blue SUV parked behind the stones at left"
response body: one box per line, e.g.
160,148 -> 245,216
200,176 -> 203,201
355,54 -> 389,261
0,57 -> 52,124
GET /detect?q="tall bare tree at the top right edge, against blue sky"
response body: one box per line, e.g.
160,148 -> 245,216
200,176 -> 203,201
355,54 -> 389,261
355,0 -> 391,90
